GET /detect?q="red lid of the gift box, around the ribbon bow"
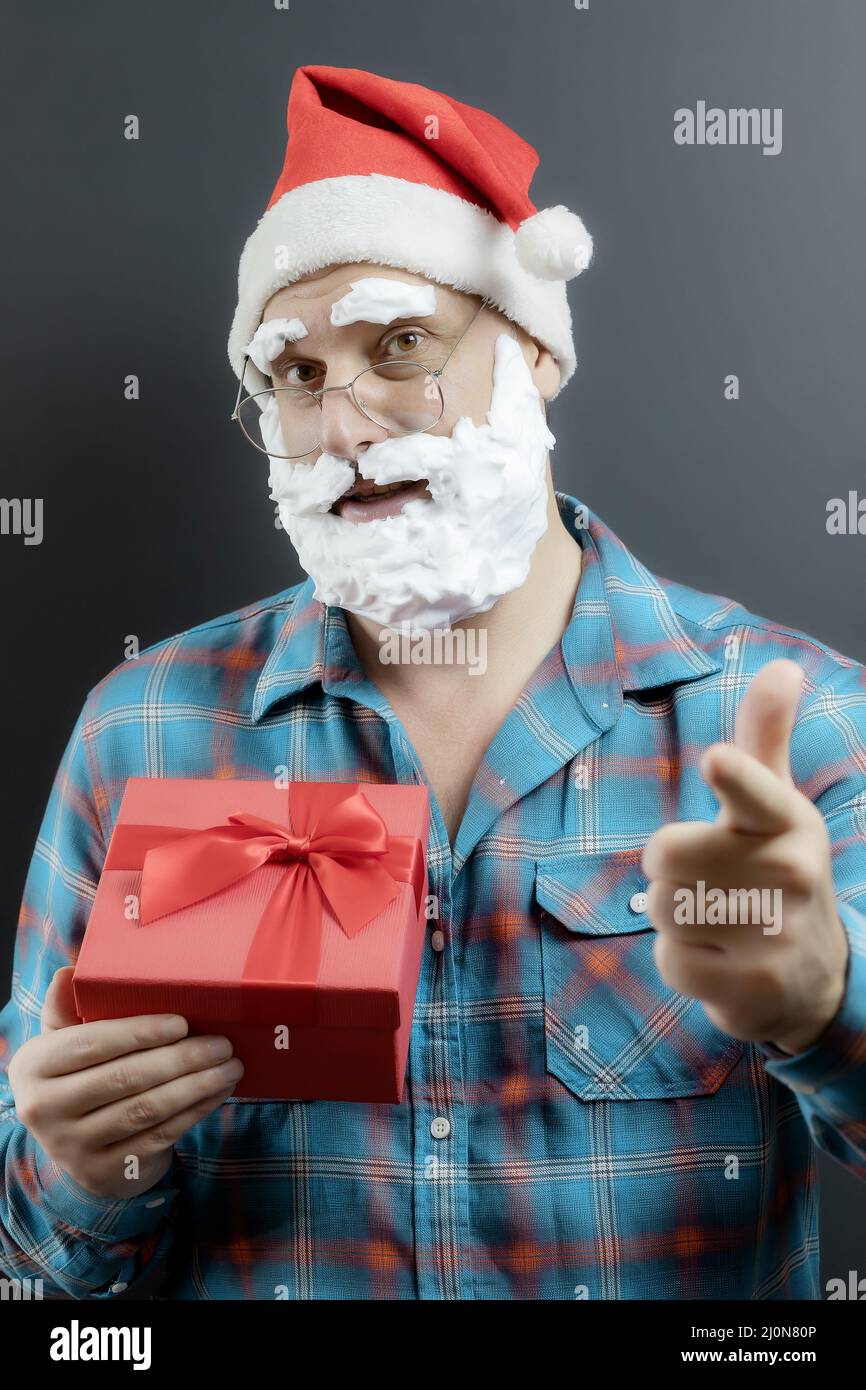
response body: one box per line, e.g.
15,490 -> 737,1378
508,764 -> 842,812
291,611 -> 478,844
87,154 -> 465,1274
72,777 -> 430,1030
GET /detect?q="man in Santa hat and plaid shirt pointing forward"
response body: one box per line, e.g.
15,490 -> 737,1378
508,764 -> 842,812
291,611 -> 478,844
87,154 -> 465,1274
0,67 -> 866,1300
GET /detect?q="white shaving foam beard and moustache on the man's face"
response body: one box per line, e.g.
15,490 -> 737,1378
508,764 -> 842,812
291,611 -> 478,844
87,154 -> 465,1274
261,334 -> 556,632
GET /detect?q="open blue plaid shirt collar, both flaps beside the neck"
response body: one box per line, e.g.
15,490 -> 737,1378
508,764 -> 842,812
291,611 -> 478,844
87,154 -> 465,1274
252,492 -> 721,727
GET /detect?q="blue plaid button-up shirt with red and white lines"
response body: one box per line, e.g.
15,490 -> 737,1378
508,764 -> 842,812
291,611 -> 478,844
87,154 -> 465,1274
0,495 -> 866,1300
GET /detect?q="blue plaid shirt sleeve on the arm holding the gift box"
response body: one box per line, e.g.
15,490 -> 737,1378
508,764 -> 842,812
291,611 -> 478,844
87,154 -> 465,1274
0,701 -> 181,1298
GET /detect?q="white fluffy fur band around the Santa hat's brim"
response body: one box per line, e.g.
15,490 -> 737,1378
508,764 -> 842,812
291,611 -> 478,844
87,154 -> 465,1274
228,174 -> 582,395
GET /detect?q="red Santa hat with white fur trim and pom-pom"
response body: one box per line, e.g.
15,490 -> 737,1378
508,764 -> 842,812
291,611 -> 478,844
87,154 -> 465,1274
228,67 -> 592,391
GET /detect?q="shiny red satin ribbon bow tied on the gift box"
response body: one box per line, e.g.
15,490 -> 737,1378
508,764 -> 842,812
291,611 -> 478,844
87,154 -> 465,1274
106,783 -> 424,984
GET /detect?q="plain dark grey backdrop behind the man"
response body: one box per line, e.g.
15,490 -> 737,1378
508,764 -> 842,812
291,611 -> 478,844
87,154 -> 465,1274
0,0 -> 866,1279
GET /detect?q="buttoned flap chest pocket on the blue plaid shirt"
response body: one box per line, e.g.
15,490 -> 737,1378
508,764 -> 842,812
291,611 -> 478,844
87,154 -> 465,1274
535,855 -> 744,1101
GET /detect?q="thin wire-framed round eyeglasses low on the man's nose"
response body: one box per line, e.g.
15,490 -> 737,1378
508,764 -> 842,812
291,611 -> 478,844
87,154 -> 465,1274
231,299 -> 489,459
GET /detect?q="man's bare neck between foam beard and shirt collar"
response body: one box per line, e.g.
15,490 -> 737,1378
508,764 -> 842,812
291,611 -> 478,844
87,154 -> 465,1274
346,467 -> 582,705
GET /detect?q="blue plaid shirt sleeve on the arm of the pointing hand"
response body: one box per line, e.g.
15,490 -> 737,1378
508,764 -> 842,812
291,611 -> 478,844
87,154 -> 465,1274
758,664 -> 866,1179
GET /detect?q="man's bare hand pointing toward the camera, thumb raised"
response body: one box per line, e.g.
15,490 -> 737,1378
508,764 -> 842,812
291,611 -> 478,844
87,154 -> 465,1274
642,659 -> 848,1054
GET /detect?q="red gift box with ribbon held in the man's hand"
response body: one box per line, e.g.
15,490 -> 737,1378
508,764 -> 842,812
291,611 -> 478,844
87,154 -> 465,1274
72,777 -> 430,1102
